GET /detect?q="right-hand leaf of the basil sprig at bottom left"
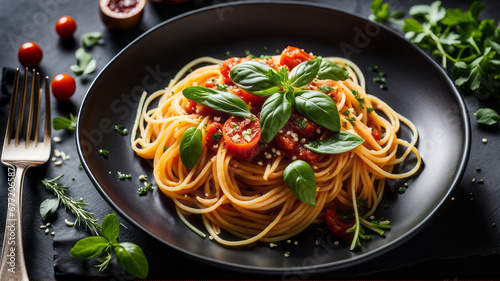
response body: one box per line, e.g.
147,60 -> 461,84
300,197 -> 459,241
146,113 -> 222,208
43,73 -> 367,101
115,242 -> 149,279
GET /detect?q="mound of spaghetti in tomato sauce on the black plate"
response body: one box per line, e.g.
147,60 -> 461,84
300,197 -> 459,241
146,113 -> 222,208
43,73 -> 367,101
131,46 -> 422,246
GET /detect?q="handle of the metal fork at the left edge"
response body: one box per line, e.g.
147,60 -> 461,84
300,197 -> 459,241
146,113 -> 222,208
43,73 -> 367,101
0,166 -> 29,280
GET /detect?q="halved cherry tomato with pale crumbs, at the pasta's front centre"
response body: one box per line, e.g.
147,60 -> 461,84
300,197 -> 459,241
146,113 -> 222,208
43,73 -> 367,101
222,116 -> 261,153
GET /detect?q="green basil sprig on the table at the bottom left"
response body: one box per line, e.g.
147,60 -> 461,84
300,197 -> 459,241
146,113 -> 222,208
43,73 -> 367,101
69,213 -> 149,279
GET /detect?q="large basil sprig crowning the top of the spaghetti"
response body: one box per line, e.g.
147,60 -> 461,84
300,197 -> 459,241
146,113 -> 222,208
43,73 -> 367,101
229,58 -> 349,142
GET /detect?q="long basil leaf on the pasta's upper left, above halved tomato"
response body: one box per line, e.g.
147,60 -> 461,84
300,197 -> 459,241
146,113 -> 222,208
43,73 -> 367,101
182,86 -> 252,118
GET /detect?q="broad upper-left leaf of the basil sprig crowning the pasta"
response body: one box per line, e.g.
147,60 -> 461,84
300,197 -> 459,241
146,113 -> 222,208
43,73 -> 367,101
229,61 -> 279,97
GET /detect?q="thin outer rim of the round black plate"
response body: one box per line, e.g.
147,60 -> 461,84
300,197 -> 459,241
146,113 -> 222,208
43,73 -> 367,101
75,0 -> 471,274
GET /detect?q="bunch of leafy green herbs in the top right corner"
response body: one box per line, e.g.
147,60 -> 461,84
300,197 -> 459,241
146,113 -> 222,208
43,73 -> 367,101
403,1 -> 500,98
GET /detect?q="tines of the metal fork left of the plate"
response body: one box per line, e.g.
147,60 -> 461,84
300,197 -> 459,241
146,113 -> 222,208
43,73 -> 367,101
4,68 -> 50,148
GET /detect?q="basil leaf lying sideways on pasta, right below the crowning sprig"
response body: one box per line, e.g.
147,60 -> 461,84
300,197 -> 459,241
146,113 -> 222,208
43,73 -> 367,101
304,131 -> 365,154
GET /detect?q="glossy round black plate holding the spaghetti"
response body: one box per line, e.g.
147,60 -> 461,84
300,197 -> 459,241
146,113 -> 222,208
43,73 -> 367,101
77,2 -> 470,273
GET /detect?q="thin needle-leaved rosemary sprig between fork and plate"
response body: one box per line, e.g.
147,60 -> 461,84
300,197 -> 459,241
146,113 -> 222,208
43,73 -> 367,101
41,175 -> 101,235
